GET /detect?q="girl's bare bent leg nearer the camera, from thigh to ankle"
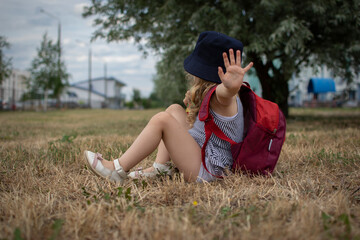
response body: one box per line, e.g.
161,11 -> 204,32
104,104 -> 201,181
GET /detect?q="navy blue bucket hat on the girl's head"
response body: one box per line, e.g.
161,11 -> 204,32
184,31 -> 243,83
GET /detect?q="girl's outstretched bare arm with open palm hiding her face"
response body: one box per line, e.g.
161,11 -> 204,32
210,49 -> 253,116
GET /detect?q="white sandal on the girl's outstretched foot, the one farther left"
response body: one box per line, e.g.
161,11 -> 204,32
84,151 -> 127,183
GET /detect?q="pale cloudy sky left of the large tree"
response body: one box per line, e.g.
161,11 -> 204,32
0,0 -> 157,99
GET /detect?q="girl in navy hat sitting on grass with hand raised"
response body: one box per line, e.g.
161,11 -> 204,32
85,31 -> 253,182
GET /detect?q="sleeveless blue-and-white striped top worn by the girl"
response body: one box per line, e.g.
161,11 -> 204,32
189,96 -> 244,175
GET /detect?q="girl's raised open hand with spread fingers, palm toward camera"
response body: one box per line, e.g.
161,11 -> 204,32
218,49 -> 253,92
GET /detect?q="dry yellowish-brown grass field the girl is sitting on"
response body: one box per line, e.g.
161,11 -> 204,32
0,109 -> 360,240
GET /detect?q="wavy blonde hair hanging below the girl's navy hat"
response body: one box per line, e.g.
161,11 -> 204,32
186,74 -> 217,127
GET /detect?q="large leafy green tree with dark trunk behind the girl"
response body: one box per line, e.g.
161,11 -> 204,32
83,0 -> 360,116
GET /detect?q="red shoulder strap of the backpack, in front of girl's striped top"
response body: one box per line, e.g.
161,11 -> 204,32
199,86 -> 236,178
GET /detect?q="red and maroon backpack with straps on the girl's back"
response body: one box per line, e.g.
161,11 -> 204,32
199,83 -> 286,178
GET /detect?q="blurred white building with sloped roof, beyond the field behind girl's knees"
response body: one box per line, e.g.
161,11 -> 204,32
61,77 -> 126,109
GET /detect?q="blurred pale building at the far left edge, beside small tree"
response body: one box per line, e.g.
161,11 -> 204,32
0,70 -> 30,109
